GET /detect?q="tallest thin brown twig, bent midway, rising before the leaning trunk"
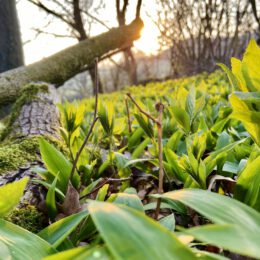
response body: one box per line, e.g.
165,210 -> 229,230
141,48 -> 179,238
70,58 -> 99,180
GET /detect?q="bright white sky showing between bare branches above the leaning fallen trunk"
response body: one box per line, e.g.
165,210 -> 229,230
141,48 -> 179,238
17,0 -> 159,64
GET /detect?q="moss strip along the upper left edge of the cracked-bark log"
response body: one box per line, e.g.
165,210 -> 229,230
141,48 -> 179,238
0,83 -> 48,141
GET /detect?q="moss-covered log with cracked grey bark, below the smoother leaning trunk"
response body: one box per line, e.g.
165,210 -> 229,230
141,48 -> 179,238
0,83 -> 61,230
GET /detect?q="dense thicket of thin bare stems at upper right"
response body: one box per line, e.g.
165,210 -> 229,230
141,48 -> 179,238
157,0 -> 253,76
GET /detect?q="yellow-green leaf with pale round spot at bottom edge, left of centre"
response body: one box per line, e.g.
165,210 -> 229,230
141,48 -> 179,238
43,246 -> 111,260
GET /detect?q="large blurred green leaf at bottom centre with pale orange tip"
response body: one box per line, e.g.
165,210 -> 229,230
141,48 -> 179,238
88,202 -> 195,259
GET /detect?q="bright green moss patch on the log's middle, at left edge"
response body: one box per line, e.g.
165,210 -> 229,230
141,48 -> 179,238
0,137 -> 39,174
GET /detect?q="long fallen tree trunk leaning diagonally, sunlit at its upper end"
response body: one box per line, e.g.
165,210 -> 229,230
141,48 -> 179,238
0,19 -> 143,107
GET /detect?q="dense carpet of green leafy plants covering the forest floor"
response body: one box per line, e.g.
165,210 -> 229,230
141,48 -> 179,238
0,41 -> 260,260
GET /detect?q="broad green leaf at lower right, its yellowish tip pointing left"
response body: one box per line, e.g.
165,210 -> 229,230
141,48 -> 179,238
156,189 -> 260,231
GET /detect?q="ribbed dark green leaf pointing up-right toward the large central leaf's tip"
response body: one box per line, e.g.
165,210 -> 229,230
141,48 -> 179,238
38,210 -> 88,248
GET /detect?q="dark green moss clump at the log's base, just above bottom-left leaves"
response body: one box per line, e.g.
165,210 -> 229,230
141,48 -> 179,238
5,205 -> 48,233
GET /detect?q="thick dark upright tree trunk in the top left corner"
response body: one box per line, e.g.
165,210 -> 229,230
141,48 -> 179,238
0,0 -> 23,72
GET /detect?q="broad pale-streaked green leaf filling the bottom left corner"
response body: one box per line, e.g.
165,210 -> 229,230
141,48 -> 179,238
0,219 -> 57,260
